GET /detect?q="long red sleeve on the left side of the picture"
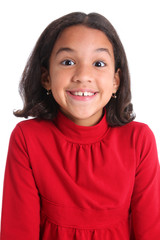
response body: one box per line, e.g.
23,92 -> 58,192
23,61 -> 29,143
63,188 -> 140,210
0,125 -> 40,240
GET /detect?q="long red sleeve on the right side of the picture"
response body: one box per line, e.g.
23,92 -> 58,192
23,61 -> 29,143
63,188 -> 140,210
131,126 -> 160,240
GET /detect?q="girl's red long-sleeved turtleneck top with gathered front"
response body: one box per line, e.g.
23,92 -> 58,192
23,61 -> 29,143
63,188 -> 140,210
1,112 -> 160,240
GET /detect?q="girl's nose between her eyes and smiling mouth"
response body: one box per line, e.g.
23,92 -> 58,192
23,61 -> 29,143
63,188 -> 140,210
72,65 -> 93,83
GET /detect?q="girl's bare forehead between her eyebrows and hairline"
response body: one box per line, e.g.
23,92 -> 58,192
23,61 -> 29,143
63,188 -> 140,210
53,25 -> 113,55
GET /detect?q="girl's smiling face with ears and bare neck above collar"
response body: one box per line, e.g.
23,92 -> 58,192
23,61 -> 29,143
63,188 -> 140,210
42,25 -> 120,126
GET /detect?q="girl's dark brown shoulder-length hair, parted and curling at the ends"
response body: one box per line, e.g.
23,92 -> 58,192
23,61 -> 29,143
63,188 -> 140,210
14,12 -> 135,126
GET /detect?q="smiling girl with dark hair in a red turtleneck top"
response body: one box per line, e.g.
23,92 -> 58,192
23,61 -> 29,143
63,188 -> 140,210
1,12 -> 160,240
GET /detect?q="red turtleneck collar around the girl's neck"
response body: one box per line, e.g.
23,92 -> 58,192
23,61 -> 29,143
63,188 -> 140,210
54,110 -> 108,144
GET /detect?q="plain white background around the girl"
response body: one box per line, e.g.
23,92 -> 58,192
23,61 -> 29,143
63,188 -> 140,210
0,0 -> 160,218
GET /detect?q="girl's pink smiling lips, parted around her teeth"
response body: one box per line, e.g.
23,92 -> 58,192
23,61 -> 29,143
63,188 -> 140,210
67,88 -> 98,101
